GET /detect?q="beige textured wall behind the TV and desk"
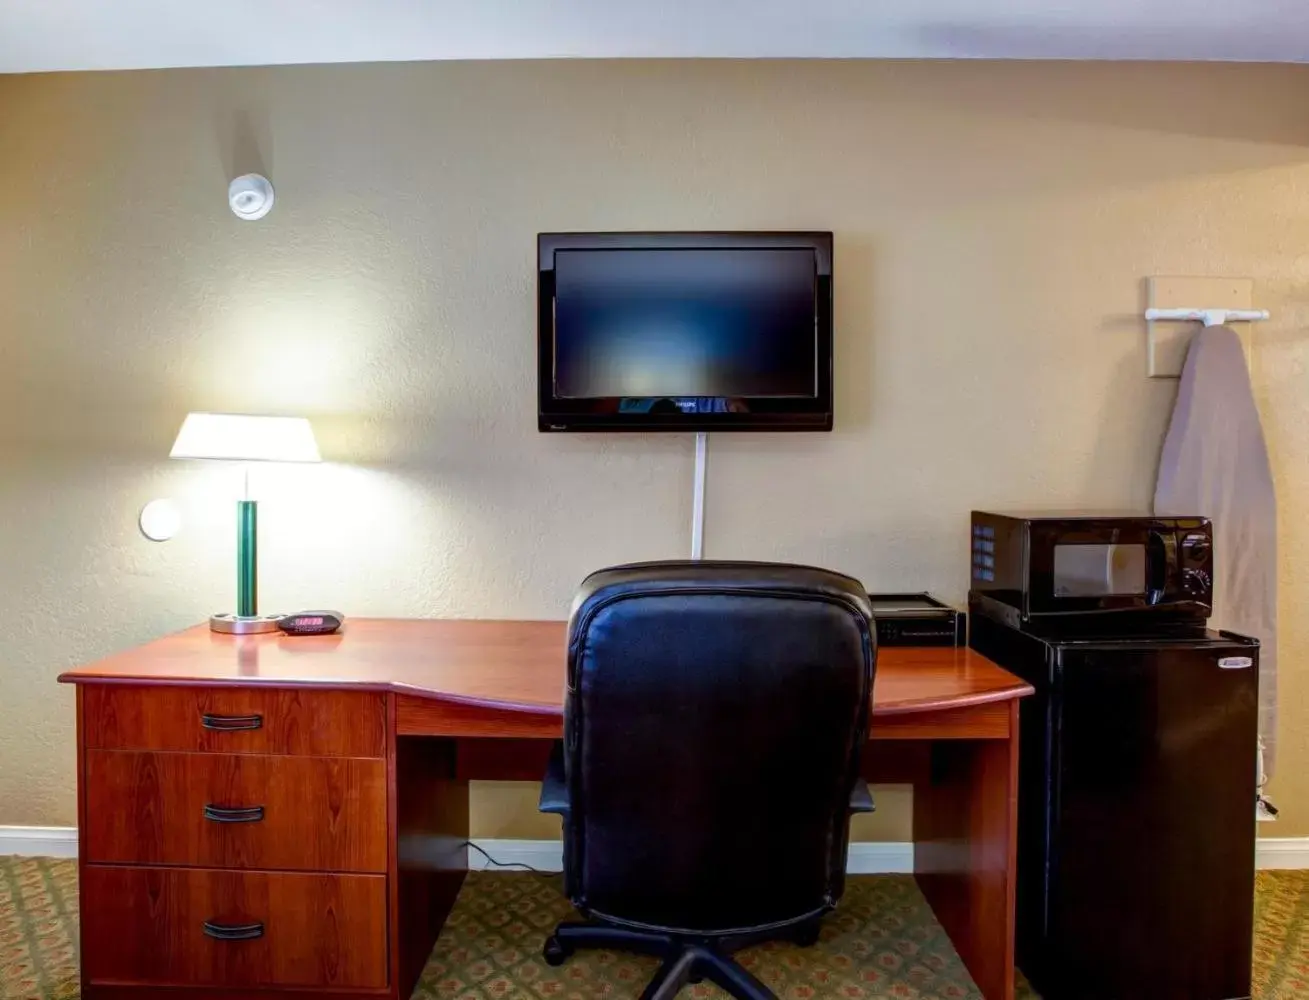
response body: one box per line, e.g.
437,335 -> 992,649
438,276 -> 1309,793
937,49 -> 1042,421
0,62 -> 1309,838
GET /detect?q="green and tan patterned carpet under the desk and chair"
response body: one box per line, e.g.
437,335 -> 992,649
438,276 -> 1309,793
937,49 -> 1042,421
0,857 -> 1309,1000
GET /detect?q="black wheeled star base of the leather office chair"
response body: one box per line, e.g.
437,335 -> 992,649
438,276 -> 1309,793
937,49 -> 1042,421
542,919 -> 819,1000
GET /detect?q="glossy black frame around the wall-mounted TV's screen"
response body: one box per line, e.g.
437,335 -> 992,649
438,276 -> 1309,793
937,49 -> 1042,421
537,232 -> 833,432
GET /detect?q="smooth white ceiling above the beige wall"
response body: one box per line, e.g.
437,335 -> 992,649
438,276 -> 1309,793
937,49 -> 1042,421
0,0 -> 1309,73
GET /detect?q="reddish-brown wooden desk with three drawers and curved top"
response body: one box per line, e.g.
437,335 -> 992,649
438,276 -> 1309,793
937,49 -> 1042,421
59,619 -> 1031,1000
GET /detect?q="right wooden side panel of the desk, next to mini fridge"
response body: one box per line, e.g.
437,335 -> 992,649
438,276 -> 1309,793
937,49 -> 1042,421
914,702 -> 1018,1000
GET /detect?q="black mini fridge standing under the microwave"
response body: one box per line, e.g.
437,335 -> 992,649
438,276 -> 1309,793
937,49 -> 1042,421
969,609 -> 1259,1000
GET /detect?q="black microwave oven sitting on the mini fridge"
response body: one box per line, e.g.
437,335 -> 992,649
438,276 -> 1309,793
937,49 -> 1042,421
970,510 -> 1213,628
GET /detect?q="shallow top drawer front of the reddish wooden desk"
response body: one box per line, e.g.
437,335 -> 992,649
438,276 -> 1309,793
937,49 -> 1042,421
82,685 -> 386,757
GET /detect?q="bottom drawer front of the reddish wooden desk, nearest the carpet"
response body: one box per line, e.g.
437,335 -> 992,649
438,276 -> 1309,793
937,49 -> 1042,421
81,865 -> 386,988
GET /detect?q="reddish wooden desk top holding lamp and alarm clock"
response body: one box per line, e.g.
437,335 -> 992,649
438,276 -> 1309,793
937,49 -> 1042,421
59,618 -> 1031,716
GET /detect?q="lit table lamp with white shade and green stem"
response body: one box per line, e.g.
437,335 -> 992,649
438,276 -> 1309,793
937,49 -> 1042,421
169,414 -> 322,635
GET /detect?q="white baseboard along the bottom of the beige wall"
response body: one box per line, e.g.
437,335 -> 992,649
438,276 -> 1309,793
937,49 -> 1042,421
0,826 -> 1309,874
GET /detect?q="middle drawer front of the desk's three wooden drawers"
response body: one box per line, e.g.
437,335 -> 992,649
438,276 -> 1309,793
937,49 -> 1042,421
84,750 -> 386,872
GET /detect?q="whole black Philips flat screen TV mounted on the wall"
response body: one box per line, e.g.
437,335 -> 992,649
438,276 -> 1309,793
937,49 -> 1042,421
537,233 -> 833,431
